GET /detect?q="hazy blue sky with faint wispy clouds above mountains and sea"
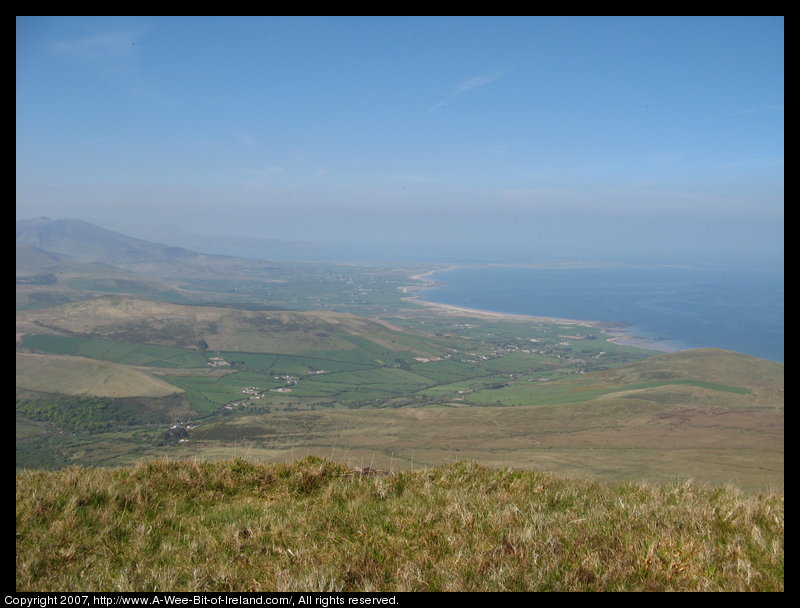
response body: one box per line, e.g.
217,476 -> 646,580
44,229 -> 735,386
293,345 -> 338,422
16,17 -> 784,264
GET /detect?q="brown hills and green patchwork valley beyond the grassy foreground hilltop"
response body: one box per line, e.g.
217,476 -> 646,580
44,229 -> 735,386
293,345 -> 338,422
17,296 -> 784,491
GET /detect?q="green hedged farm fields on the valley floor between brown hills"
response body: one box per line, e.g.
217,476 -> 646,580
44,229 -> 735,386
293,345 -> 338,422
20,308 -> 648,415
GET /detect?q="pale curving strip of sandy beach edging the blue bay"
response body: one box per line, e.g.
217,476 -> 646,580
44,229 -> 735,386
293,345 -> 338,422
402,264 -> 683,353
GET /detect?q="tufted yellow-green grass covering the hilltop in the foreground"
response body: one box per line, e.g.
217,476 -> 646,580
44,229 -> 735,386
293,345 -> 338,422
16,457 -> 784,591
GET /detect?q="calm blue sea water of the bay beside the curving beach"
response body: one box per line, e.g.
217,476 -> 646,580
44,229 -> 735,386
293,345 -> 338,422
422,267 -> 784,361
